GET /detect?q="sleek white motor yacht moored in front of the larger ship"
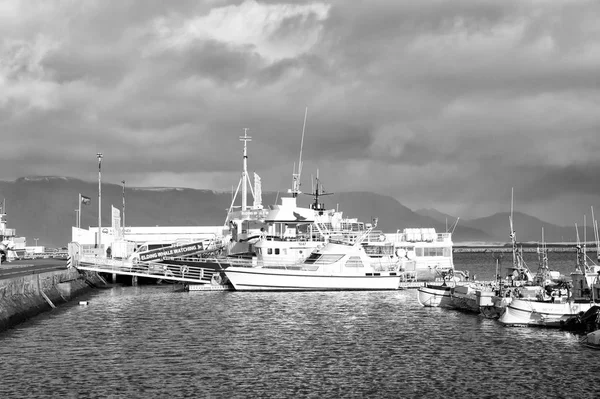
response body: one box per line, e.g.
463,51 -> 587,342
225,227 -> 401,291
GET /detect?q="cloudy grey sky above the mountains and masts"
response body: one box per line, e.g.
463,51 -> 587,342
0,0 -> 600,225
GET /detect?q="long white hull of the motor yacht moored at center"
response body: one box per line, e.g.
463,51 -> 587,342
225,266 -> 400,291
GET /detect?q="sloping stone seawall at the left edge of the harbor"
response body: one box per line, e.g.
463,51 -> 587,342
0,269 -> 102,331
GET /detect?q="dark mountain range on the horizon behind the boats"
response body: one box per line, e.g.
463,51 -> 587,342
0,176 -> 593,247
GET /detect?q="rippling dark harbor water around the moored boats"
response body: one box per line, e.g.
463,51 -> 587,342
0,254 -> 600,398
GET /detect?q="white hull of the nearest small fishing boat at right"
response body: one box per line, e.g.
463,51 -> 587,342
498,299 -> 594,328
